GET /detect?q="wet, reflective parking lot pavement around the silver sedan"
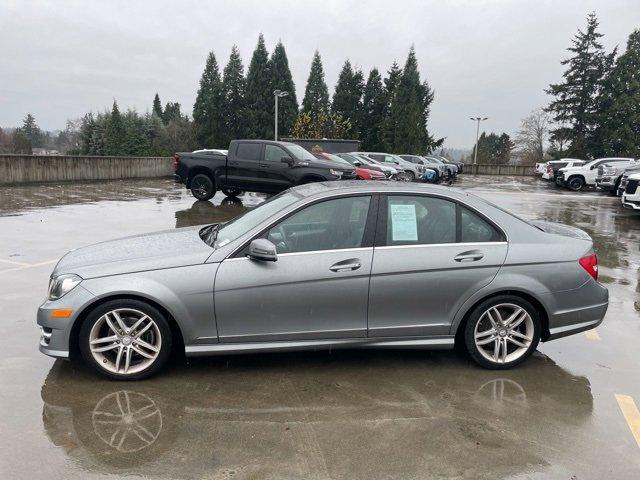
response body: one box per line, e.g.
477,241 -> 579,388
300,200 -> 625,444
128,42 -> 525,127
0,176 -> 640,480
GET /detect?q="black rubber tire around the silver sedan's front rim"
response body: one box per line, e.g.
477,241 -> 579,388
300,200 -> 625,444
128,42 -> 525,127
78,299 -> 172,380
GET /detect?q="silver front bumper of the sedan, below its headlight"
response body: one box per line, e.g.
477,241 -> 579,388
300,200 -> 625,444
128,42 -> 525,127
37,284 -> 95,358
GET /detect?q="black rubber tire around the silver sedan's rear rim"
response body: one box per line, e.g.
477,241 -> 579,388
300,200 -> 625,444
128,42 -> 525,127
464,295 -> 542,370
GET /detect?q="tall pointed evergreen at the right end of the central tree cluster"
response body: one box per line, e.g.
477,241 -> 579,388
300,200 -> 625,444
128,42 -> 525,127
389,47 -> 436,153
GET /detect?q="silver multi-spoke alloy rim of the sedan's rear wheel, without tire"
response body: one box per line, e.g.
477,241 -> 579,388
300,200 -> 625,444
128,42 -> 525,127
474,303 -> 535,364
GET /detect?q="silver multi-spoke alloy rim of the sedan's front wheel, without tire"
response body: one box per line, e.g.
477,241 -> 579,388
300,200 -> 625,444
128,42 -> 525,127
89,308 -> 162,375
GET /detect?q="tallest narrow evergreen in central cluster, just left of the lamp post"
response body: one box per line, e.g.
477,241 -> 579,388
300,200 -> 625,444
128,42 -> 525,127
245,34 -> 273,139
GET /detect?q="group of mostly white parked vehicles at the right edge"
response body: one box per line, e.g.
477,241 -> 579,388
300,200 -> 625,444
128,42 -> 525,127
534,157 -> 640,210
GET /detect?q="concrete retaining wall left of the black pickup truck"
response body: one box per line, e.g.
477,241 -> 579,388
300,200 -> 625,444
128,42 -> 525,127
0,155 -> 173,185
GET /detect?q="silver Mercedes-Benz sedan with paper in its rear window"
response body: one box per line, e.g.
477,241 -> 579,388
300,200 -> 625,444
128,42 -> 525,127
38,181 -> 608,380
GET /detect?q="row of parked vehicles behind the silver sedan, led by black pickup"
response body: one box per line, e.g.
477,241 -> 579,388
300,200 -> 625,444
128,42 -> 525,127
173,140 -> 463,200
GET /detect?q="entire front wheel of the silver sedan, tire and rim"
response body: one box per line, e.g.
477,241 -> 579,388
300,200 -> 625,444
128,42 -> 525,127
79,300 -> 172,380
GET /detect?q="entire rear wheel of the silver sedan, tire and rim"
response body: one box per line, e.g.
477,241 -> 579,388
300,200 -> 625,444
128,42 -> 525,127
464,295 -> 541,370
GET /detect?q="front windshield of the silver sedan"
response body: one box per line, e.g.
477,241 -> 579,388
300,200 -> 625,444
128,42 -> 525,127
206,192 -> 302,248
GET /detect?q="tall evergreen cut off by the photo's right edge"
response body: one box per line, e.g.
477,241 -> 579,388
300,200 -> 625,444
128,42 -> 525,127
600,30 -> 640,158
